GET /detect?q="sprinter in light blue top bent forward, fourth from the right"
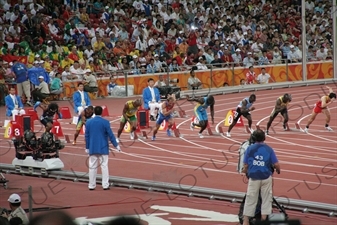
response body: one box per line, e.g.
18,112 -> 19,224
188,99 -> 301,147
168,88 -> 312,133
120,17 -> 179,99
187,95 -> 215,138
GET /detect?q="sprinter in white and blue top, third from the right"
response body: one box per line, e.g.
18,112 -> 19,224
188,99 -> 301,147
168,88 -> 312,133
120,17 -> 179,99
226,94 -> 256,137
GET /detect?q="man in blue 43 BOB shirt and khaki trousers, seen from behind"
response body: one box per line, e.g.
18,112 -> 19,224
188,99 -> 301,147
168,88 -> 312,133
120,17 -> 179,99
241,130 -> 281,225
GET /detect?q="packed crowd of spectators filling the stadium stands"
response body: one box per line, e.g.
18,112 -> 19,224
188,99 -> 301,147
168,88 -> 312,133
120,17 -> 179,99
0,0 -> 333,104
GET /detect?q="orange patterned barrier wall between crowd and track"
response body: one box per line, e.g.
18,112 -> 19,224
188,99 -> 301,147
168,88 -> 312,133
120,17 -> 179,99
55,61 -> 333,97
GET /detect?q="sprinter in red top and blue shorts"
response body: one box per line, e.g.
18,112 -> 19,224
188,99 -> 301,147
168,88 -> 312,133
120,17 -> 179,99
152,94 -> 176,141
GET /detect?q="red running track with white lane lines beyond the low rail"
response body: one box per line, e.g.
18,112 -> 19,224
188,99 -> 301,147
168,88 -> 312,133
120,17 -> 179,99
0,86 -> 337,207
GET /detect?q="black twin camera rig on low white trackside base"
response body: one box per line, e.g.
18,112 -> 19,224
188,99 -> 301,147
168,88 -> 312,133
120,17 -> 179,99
12,130 -> 64,161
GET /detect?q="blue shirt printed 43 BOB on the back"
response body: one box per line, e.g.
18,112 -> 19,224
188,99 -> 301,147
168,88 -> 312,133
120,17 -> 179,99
243,143 -> 278,180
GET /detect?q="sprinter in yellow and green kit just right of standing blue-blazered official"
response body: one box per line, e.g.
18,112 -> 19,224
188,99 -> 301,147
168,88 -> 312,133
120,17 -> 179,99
117,98 -> 142,142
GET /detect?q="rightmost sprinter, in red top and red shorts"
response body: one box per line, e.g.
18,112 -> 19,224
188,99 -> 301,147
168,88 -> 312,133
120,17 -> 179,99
304,87 -> 336,133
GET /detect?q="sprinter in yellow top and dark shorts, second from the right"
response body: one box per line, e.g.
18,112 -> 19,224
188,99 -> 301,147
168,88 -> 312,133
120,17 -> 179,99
266,94 -> 292,135
